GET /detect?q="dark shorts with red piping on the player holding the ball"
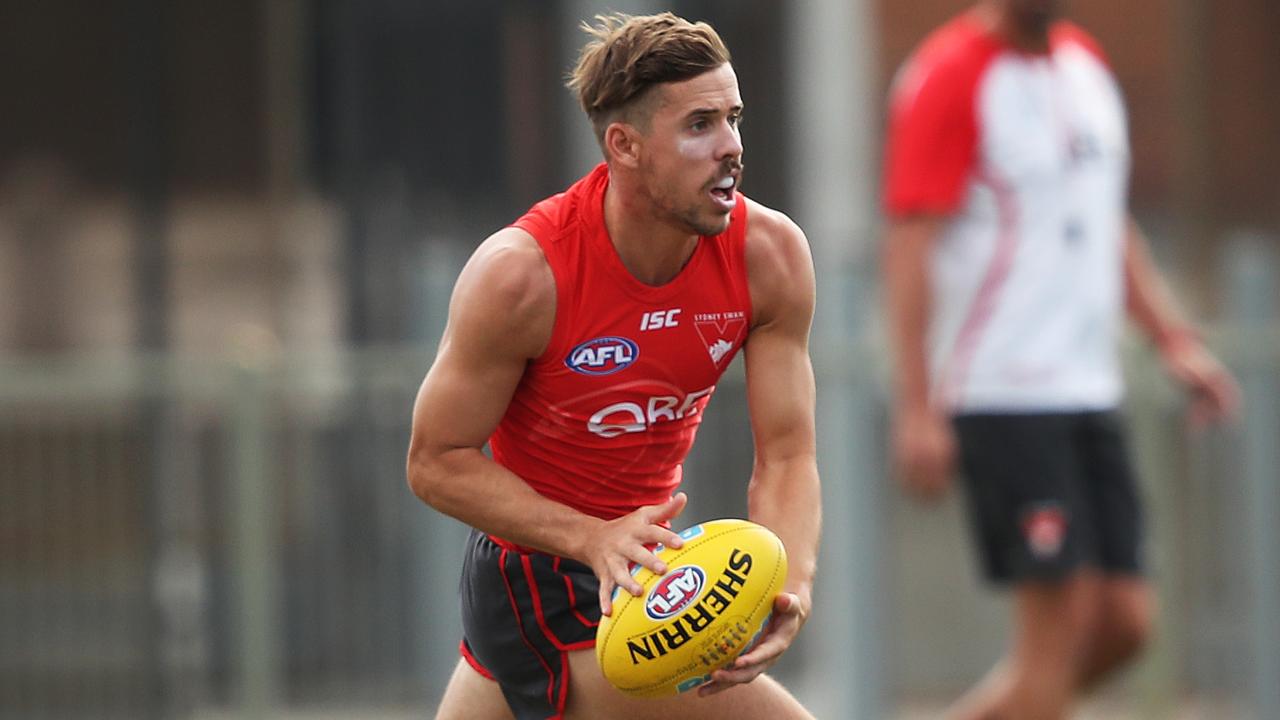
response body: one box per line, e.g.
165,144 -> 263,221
461,530 -> 600,720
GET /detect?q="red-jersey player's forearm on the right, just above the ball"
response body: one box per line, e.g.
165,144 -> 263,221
748,454 -> 822,610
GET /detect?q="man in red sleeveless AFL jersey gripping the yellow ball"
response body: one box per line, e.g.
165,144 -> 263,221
407,13 -> 820,720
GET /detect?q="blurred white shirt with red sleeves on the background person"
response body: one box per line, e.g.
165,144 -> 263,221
884,13 -> 1129,411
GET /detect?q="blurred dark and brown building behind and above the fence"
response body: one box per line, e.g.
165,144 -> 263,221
0,0 -> 1280,352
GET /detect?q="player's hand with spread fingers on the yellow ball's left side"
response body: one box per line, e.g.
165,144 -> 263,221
582,492 -> 689,615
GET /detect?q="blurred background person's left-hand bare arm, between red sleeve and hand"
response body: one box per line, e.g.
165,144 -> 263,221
884,222 -> 932,410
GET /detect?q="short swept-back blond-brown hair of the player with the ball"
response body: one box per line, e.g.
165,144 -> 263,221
567,13 -> 730,145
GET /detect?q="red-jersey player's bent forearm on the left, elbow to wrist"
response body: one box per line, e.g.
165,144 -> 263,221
407,447 -> 603,560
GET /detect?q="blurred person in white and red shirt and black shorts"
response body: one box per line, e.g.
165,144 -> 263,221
883,0 -> 1238,719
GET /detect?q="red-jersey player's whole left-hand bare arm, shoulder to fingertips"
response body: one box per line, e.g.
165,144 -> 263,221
406,228 -> 685,614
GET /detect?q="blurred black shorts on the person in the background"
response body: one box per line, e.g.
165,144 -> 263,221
954,411 -> 1142,584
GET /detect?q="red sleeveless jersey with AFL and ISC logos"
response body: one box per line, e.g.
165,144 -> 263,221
489,164 -> 751,519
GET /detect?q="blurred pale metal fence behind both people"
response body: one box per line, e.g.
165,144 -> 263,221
0,244 -> 1280,720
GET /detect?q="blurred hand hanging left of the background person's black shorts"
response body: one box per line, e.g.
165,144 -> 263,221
893,409 -> 956,500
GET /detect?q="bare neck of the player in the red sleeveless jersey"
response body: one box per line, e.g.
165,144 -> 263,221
604,182 -> 698,287
